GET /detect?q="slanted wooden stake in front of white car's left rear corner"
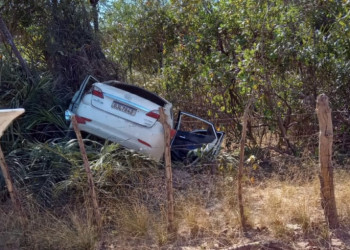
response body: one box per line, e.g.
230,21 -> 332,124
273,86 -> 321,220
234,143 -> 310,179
71,115 -> 102,228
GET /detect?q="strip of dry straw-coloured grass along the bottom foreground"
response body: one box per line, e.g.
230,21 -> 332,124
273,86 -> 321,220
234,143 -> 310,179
0,165 -> 350,249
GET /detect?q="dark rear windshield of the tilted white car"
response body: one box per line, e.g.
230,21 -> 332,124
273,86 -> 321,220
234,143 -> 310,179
103,82 -> 167,107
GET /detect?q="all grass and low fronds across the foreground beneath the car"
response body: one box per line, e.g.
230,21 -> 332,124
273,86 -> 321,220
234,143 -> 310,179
0,143 -> 350,249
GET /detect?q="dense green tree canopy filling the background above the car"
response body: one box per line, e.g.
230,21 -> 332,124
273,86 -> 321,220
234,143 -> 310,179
1,0 -> 350,154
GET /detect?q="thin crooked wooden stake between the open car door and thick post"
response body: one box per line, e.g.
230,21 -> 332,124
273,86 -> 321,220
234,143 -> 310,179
237,98 -> 253,232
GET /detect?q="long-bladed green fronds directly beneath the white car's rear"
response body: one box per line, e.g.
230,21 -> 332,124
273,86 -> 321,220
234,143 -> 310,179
0,139 -> 157,206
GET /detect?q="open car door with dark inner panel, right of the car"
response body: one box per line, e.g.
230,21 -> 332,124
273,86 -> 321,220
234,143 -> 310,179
171,111 -> 225,163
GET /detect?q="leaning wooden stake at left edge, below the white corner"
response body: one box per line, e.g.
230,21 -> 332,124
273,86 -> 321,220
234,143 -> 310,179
0,147 -> 23,216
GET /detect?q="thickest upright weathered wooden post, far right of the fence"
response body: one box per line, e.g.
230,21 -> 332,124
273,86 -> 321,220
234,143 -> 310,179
316,94 -> 339,228
